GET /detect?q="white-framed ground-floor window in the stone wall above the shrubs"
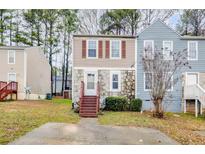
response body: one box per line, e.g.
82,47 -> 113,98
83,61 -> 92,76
110,71 -> 121,91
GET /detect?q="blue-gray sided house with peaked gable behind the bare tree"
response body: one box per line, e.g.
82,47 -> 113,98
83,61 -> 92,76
136,20 -> 205,112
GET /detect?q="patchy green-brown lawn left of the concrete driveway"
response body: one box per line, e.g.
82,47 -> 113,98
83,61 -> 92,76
0,99 -> 79,144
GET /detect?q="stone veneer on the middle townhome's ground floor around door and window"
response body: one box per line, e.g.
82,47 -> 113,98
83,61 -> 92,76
73,69 -> 135,107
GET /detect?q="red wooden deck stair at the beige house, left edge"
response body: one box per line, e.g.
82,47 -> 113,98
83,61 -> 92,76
0,81 -> 18,101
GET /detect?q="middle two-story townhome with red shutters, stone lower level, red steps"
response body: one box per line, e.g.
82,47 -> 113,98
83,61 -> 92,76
72,35 -> 135,116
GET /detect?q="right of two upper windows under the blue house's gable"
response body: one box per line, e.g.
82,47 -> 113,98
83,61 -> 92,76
163,41 -> 173,60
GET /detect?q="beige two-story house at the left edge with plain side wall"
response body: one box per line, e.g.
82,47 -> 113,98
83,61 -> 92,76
0,46 -> 51,100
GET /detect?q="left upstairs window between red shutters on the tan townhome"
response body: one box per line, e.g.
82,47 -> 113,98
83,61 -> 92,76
87,40 -> 97,58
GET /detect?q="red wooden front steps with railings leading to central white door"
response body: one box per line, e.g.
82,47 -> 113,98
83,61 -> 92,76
79,81 -> 99,117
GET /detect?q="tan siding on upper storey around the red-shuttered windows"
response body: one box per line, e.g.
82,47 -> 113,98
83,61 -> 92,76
73,37 -> 135,68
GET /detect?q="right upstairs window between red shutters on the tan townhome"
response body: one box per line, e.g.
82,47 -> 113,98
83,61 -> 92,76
110,40 -> 121,59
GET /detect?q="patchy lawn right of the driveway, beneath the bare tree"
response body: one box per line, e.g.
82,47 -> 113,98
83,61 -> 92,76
99,112 -> 205,144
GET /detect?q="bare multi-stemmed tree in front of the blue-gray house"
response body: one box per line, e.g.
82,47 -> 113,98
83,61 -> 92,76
142,48 -> 190,118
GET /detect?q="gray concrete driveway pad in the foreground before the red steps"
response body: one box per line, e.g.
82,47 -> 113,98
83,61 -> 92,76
10,118 -> 178,145
